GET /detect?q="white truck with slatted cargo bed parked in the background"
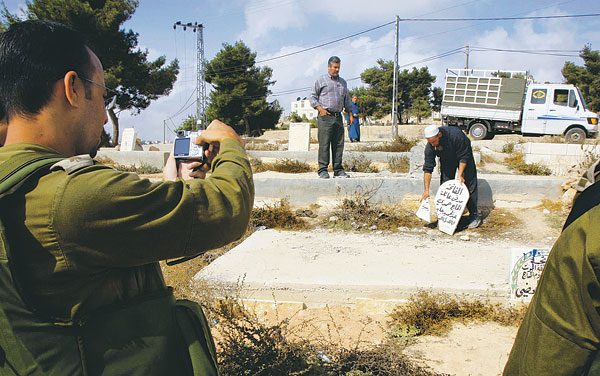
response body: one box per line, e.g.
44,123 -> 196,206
441,69 -> 598,143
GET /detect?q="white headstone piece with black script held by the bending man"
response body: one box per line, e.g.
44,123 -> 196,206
435,179 -> 469,235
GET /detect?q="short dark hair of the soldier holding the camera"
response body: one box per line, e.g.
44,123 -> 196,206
0,20 -> 93,119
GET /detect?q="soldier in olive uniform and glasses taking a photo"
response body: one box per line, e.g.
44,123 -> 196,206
0,21 -> 254,375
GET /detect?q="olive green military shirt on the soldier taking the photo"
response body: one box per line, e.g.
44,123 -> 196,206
0,139 -> 254,320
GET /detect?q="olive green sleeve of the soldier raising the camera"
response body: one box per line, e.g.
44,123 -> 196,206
52,139 -> 254,270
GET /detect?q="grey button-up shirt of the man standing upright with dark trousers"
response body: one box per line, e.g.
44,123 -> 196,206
308,74 -> 352,112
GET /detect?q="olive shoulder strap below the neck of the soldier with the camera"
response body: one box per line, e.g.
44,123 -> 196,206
0,154 -> 65,197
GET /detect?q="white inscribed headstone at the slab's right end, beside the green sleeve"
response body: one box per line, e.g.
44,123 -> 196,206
509,248 -> 550,302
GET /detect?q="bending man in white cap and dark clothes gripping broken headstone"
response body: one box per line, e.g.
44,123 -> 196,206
421,125 -> 481,228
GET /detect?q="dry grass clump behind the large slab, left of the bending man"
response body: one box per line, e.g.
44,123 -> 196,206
327,197 -> 421,232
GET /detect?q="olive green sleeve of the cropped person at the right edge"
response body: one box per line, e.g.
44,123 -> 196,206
504,207 -> 600,375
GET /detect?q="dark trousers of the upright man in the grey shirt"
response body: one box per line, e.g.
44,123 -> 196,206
317,113 -> 344,174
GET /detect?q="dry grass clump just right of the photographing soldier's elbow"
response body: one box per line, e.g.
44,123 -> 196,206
250,199 -> 308,230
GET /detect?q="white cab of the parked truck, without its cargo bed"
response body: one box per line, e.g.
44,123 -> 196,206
521,84 -> 598,143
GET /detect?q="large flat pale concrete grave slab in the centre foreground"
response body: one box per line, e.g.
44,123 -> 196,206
194,230 -> 548,309
